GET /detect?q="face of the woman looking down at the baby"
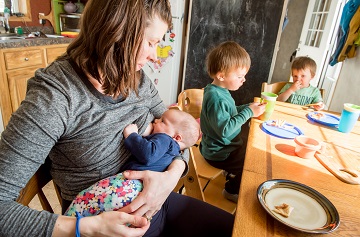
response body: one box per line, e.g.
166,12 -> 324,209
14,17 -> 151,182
136,17 -> 168,71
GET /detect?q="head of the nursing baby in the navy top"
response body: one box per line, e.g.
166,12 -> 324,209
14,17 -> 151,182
152,109 -> 200,150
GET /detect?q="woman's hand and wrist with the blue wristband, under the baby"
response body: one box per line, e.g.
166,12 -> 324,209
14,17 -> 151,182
53,211 -> 150,237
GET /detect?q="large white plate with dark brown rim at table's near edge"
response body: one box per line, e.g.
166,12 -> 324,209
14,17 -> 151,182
257,179 -> 340,234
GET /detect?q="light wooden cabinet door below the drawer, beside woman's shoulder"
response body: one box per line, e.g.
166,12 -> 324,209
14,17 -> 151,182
7,68 -> 37,112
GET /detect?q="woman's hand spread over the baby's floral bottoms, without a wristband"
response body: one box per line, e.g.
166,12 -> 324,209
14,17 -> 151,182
121,160 -> 185,218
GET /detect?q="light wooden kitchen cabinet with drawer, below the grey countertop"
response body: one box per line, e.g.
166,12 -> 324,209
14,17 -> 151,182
0,44 -> 67,127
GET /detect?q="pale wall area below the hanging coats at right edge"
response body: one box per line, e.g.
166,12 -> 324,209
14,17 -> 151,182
329,49 -> 360,112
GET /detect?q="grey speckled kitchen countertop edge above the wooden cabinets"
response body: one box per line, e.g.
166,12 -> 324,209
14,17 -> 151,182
0,37 -> 73,49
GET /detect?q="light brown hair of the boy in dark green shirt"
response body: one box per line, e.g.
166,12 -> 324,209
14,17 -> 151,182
206,41 -> 251,77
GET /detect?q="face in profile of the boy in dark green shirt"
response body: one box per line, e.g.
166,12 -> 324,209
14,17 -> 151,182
214,67 -> 248,91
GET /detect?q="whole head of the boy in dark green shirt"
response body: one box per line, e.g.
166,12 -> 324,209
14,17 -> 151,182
206,41 -> 251,91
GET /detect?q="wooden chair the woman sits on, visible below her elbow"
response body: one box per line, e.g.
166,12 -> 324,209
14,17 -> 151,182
16,159 -> 61,213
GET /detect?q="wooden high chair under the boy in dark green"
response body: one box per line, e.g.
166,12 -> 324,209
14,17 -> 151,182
171,89 -> 236,213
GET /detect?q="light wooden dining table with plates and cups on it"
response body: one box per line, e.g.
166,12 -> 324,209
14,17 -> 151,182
233,102 -> 360,237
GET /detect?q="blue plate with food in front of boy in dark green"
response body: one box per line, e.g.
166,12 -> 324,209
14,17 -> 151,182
262,120 -> 304,139
